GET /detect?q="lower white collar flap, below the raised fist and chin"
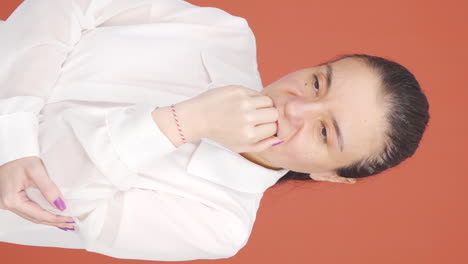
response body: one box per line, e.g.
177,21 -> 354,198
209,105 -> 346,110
187,138 -> 289,193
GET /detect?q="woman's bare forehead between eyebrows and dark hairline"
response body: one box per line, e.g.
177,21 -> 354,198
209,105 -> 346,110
326,58 -> 387,164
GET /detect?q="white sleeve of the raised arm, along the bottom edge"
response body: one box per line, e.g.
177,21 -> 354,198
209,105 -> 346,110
86,188 -> 261,261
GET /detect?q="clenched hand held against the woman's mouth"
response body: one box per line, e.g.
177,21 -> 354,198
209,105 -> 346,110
183,85 -> 280,153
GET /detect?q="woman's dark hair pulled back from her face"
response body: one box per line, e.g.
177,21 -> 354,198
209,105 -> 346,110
275,54 -> 429,185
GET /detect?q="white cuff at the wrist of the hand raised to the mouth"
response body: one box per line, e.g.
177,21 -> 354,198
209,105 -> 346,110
62,103 -> 176,191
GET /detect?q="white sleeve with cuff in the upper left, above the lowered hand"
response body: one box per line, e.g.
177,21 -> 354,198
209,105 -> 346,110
0,0 -> 192,165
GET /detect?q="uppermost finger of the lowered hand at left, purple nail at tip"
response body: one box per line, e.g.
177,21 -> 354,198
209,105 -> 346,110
25,160 -> 67,211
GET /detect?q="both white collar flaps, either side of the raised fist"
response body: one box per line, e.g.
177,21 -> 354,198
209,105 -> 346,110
187,47 -> 289,193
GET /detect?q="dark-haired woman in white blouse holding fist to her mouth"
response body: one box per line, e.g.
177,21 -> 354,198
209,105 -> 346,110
0,0 -> 429,260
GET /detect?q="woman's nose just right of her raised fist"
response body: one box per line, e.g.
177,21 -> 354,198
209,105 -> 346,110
284,96 -> 324,126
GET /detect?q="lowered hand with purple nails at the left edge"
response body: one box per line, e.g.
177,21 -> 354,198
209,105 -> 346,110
0,156 -> 74,230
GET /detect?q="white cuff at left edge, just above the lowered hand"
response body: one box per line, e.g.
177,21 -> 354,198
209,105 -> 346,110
0,112 -> 39,166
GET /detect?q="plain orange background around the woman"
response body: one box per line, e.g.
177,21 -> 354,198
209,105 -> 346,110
0,0 -> 468,264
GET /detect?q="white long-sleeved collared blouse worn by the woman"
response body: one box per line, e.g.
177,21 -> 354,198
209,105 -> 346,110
0,0 -> 288,261
